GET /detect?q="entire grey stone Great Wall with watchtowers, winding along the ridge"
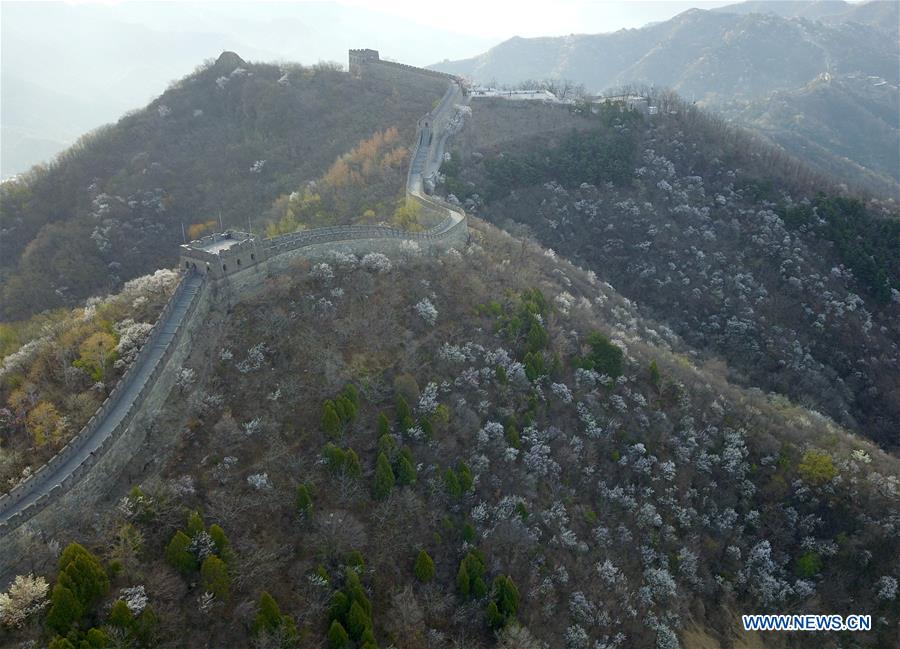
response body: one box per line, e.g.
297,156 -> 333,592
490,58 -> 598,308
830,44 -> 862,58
0,50 -> 468,576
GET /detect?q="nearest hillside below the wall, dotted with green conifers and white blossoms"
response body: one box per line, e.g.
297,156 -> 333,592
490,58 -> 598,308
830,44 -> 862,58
1,220 -> 900,649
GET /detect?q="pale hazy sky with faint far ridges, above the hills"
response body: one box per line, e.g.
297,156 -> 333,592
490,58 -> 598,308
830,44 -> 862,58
0,0 -> 840,176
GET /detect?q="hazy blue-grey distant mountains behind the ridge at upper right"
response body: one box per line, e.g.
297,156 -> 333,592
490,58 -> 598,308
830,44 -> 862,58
432,3 -> 900,196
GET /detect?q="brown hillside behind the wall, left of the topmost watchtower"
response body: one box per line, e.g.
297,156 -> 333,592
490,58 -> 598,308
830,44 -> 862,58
0,53 -> 444,321
